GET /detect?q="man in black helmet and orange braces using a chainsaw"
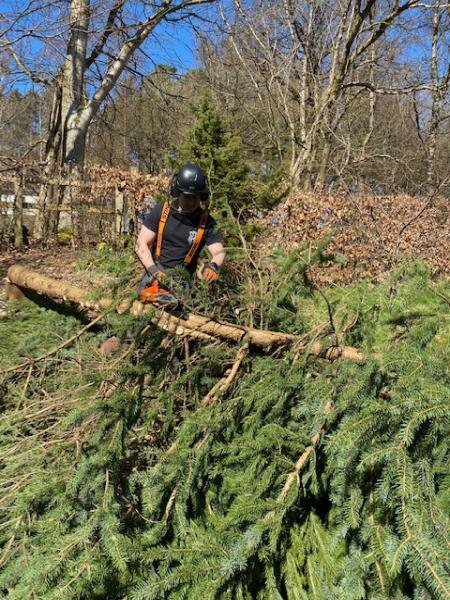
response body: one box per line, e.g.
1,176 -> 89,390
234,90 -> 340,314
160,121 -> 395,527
136,163 -> 225,306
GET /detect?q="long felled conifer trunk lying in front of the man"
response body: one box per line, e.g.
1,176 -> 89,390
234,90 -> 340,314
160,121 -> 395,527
8,265 -> 379,361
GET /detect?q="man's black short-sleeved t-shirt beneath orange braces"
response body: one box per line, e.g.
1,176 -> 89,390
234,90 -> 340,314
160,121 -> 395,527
143,204 -> 223,271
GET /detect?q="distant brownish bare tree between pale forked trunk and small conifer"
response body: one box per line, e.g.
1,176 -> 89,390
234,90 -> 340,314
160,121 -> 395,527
88,64 -> 197,174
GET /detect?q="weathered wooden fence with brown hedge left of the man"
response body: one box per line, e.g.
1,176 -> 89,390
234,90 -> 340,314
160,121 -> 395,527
0,162 -> 167,247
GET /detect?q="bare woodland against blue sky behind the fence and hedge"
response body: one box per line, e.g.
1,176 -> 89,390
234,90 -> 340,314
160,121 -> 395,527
0,0 -> 450,195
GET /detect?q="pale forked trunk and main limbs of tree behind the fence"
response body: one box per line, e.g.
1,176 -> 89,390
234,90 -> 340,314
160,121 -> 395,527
31,0 -> 216,239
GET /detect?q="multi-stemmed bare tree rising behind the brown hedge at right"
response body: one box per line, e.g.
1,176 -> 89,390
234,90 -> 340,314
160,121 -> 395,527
210,0 -> 435,188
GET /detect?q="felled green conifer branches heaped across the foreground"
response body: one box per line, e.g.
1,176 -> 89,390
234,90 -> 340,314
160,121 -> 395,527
0,252 -> 450,600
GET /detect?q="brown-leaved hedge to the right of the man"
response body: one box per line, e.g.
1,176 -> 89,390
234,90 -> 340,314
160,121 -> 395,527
256,193 -> 450,284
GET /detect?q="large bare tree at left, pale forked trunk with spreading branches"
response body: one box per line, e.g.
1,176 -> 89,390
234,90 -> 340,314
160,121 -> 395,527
0,0 -> 215,235
